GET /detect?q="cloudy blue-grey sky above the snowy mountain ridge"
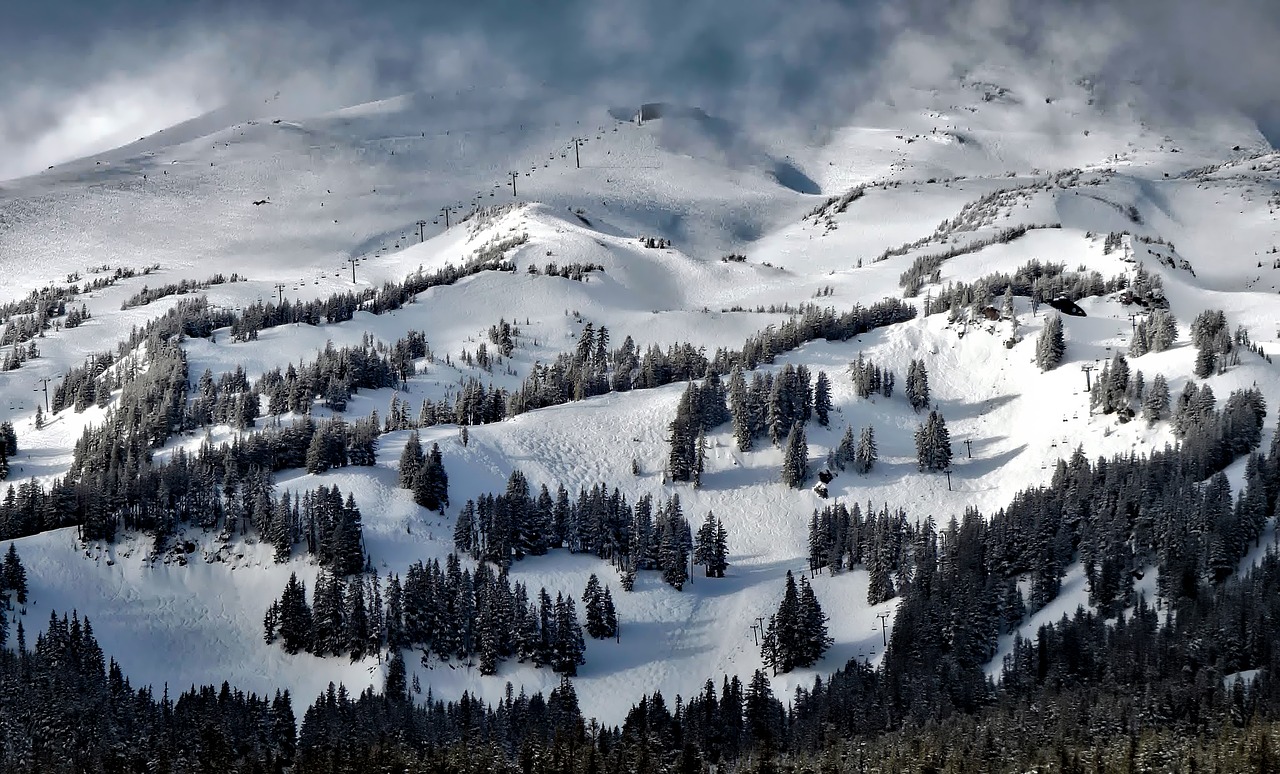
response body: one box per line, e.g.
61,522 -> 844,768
0,0 -> 1280,179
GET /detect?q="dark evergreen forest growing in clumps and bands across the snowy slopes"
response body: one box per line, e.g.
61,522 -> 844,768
0,237 -> 1280,774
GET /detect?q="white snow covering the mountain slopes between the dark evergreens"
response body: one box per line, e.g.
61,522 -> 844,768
0,67 -> 1280,723
